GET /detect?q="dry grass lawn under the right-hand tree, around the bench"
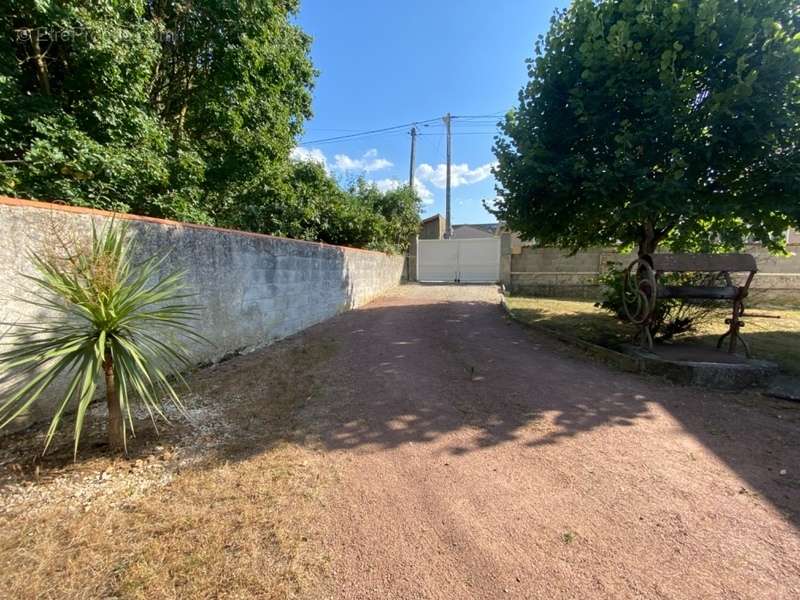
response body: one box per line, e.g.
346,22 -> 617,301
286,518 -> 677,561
508,296 -> 800,374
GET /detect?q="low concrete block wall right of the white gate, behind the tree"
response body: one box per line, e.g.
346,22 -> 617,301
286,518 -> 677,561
510,243 -> 800,302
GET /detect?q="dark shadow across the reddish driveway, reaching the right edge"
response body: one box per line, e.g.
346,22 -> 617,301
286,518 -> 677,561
188,302 -> 800,526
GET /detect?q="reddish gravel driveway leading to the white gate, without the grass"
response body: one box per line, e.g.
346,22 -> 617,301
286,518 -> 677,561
306,285 -> 800,599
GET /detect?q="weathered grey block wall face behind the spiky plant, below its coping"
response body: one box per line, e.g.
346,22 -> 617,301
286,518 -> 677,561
0,197 -> 405,427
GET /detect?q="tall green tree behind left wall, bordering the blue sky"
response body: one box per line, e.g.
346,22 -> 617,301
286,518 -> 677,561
145,0 -> 316,220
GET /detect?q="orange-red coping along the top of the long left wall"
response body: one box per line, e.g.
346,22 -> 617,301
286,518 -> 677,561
0,194 -> 394,258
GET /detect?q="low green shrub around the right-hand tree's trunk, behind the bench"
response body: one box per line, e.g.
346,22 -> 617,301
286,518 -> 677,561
595,262 -> 715,340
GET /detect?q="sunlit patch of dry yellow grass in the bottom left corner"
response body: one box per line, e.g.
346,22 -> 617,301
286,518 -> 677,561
0,446 -> 322,598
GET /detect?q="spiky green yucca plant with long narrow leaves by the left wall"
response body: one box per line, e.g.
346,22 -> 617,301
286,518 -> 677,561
0,221 -> 203,456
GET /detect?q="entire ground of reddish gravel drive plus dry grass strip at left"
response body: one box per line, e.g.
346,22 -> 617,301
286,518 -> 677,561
0,285 -> 800,599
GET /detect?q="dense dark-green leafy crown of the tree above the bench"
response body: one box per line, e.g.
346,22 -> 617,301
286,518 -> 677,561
493,0 -> 800,253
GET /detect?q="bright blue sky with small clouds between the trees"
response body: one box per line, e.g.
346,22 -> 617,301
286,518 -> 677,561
294,0 -> 568,223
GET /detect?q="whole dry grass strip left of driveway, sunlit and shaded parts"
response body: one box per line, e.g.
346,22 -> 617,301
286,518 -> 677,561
0,340 -> 334,598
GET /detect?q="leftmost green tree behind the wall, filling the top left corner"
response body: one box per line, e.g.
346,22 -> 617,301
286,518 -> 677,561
0,0 -> 170,214
